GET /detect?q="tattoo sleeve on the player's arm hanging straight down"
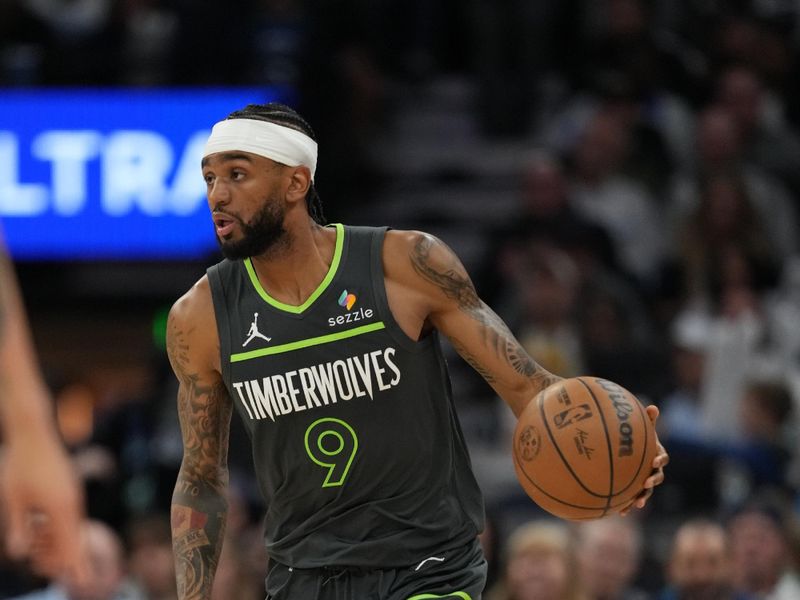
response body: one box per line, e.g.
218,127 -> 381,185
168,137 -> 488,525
167,316 -> 232,600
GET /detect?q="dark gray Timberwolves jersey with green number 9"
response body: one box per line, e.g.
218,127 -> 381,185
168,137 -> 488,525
208,225 -> 483,568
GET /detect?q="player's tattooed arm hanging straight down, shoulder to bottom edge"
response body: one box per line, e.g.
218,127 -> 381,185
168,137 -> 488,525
167,277 -> 232,600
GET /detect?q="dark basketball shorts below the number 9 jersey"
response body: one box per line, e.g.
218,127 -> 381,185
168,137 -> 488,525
266,539 -> 487,600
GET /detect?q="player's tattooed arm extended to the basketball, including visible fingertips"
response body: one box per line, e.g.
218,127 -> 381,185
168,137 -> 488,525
385,231 -> 669,508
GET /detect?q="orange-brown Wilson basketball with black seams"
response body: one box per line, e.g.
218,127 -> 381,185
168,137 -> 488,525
513,377 -> 656,521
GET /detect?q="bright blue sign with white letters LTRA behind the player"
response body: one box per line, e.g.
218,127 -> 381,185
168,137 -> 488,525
0,88 -> 279,260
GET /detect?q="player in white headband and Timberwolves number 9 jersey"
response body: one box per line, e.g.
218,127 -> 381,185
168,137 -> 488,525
167,104 -> 667,600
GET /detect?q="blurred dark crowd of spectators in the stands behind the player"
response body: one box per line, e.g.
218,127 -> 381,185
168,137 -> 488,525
0,0 -> 800,600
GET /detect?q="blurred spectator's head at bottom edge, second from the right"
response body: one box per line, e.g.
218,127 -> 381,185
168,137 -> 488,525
658,519 -> 755,600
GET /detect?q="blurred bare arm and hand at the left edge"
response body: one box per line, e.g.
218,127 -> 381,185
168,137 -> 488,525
0,238 -> 87,580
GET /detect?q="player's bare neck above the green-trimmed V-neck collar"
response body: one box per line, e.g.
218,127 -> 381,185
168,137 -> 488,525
247,219 -> 336,306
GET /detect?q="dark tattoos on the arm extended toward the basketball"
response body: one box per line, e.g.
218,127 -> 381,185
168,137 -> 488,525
411,235 -> 557,386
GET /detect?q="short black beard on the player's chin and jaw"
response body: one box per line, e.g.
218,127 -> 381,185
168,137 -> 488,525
217,196 -> 289,260
